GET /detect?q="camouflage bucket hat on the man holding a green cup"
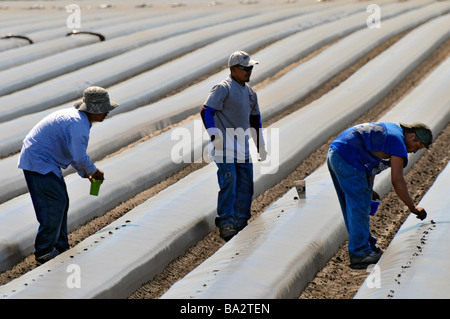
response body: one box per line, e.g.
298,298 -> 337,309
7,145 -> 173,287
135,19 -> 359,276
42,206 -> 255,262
74,86 -> 119,114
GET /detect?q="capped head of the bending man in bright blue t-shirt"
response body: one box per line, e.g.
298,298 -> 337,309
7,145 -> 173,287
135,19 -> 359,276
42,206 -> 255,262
400,122 -> 433,153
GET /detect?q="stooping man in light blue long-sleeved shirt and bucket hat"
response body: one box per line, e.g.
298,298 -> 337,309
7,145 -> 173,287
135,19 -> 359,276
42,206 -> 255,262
18,86 -> 118,263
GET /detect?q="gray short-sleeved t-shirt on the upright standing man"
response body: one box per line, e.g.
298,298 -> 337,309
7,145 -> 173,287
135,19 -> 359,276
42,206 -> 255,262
204,76 -> 260,160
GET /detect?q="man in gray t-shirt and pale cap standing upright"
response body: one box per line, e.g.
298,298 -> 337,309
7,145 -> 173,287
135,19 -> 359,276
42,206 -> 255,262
201,51 -> 267,240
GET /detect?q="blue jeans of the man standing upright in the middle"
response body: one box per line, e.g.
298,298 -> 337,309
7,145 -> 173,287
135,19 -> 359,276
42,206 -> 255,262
215,161 -> 253,230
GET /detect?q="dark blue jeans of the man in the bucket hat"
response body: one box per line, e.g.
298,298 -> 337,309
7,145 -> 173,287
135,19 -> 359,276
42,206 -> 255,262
23,170 -> 69,256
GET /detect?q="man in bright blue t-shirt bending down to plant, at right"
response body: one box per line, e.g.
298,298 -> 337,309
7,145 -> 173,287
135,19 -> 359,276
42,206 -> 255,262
327,122 -> 433,268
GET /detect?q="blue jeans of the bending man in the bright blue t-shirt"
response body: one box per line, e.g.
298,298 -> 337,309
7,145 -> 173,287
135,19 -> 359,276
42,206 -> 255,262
327,148 -> 376,258
